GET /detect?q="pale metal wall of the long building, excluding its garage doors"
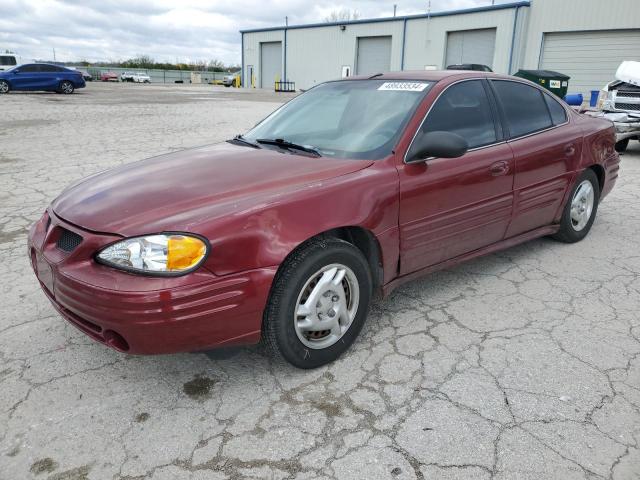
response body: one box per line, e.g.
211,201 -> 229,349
243,0 -> 640,89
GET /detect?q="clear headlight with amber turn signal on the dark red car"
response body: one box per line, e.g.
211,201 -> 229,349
96,233 -> 208,275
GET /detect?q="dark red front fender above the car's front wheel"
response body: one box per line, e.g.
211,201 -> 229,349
201,161 -> 399,275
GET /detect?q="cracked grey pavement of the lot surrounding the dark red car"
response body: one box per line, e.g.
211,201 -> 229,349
0,83 -> 640,480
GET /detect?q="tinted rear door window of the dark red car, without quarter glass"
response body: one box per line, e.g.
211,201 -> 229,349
492,80 -> 553,138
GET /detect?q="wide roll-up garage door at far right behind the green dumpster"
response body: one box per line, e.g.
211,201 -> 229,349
540,30 -> 640,94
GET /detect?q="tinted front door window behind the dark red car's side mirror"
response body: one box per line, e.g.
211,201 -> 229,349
419,80 -> 497,149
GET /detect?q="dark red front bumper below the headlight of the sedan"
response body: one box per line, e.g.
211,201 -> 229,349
28,211 -> 275,354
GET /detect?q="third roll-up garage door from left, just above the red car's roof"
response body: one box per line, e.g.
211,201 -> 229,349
445,28 -> 496,68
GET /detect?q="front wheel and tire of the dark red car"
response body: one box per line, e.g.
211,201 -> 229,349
263,238 -> 372,369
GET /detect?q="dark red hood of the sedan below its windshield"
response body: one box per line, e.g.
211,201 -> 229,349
52,143 -> 372,236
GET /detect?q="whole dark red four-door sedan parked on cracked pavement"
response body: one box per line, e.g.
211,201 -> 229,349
29,71 -> 619,368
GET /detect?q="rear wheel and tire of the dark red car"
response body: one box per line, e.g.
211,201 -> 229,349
553,169 -> 600,243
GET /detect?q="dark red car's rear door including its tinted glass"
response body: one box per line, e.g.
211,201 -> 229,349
490,80 -> 582,237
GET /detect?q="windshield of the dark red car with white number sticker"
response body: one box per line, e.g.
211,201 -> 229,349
243,80 -> 432,160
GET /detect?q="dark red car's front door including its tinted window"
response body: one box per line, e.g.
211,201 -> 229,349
399,80 -> 514,275
